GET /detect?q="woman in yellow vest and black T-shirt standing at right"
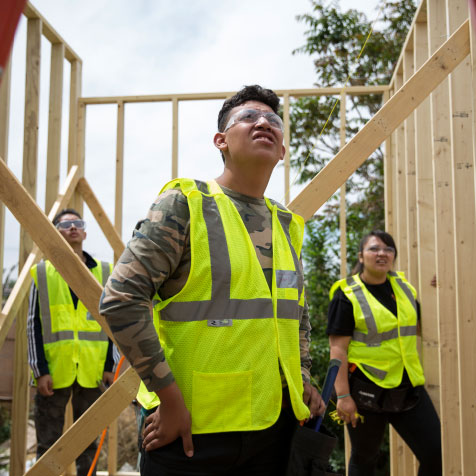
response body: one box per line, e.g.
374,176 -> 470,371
327,231 -> 441,476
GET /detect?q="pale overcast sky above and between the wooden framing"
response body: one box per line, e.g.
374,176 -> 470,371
4,0 -> 378,276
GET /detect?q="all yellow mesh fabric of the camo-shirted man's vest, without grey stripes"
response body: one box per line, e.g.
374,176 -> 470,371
138,180 -> 309,433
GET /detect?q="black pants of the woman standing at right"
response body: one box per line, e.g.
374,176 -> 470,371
347,387 -> 442,476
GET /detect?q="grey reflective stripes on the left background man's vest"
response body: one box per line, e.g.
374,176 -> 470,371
36,261 -> 109,344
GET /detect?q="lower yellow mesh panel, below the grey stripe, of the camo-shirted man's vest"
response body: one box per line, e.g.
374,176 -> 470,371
160,319 -> 282,433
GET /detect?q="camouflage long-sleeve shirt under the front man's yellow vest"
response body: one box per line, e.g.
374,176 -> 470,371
99,181 -> 311,391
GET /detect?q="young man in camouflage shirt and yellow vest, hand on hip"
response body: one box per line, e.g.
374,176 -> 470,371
100,86 -> 324,476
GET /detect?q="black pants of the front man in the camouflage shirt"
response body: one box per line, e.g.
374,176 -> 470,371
140,409 -> 297,476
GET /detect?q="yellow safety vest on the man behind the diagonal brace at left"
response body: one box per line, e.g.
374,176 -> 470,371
30,260 -> 111,388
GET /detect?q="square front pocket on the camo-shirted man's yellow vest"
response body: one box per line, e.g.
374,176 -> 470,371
192,370 -> 253,433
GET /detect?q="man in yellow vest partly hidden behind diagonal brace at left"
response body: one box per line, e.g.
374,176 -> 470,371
27,208 -> 117,476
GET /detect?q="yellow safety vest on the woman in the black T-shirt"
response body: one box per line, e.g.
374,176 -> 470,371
330,271 -> 425,388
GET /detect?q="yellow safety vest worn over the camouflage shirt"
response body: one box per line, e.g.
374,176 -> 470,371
137,179 -> 309,434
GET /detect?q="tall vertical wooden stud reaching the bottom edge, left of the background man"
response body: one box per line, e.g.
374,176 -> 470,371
10,18 -> 42,476
